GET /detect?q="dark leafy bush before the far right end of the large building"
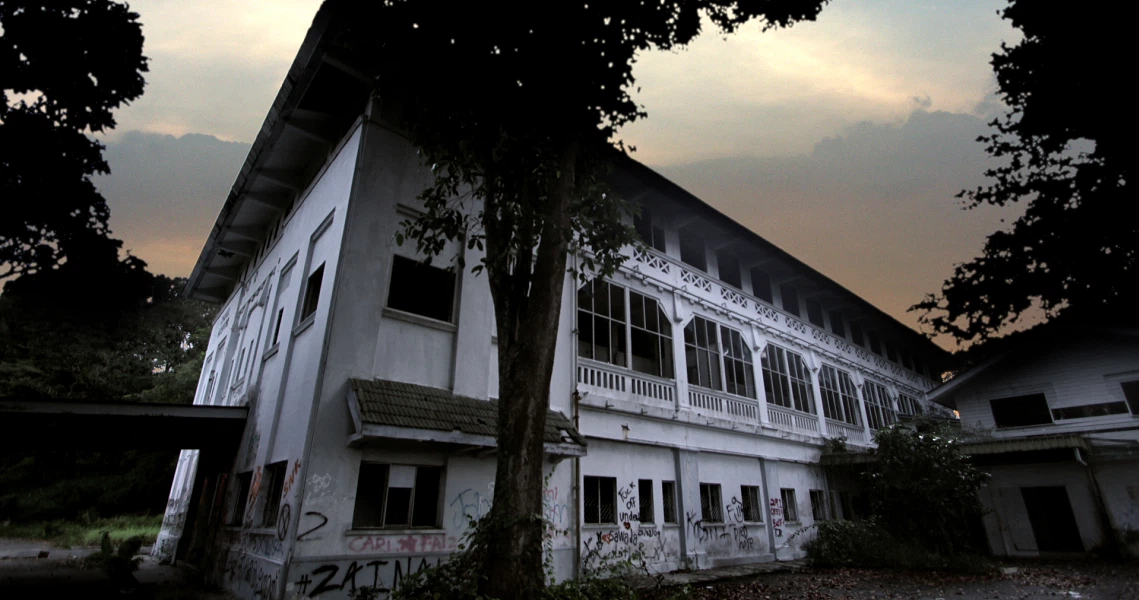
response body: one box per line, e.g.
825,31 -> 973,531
866,426 -> 989,556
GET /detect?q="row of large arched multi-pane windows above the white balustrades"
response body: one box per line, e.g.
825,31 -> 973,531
577,279 -> 923,429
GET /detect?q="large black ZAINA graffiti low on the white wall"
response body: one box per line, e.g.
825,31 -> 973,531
286,556 -> 446,600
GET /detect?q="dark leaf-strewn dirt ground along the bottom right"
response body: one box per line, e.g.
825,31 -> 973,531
647,561 -> 1139,600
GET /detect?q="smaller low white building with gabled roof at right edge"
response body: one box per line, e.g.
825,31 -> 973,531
929,326 -> 1139,557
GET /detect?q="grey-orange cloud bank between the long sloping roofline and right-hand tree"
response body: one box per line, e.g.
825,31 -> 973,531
657,109 -> 1021,346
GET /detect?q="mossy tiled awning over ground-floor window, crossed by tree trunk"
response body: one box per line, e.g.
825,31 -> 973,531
349,379 -> 585,453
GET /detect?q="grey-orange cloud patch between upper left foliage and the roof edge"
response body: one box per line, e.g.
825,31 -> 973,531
95,131 -> 249,277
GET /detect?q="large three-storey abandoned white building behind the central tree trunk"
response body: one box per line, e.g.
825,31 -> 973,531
155,5 -> 948,598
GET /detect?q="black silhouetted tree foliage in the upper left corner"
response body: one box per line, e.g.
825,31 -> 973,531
0,0 -> 147,279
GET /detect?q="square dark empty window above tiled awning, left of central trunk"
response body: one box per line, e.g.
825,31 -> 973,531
387,255 -> 454,322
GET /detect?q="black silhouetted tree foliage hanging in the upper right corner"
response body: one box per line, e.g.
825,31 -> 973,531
911,0 -> 1139,342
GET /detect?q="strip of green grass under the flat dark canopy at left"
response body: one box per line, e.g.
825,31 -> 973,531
0,515 -> 162,548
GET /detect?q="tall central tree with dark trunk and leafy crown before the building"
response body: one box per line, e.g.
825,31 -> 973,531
338,0 -> 825,599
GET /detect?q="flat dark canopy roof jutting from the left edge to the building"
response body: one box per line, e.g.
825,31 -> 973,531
0,398 -> 248,450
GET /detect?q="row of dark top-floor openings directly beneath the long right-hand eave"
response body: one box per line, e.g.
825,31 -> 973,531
633,209 -> 933,377
